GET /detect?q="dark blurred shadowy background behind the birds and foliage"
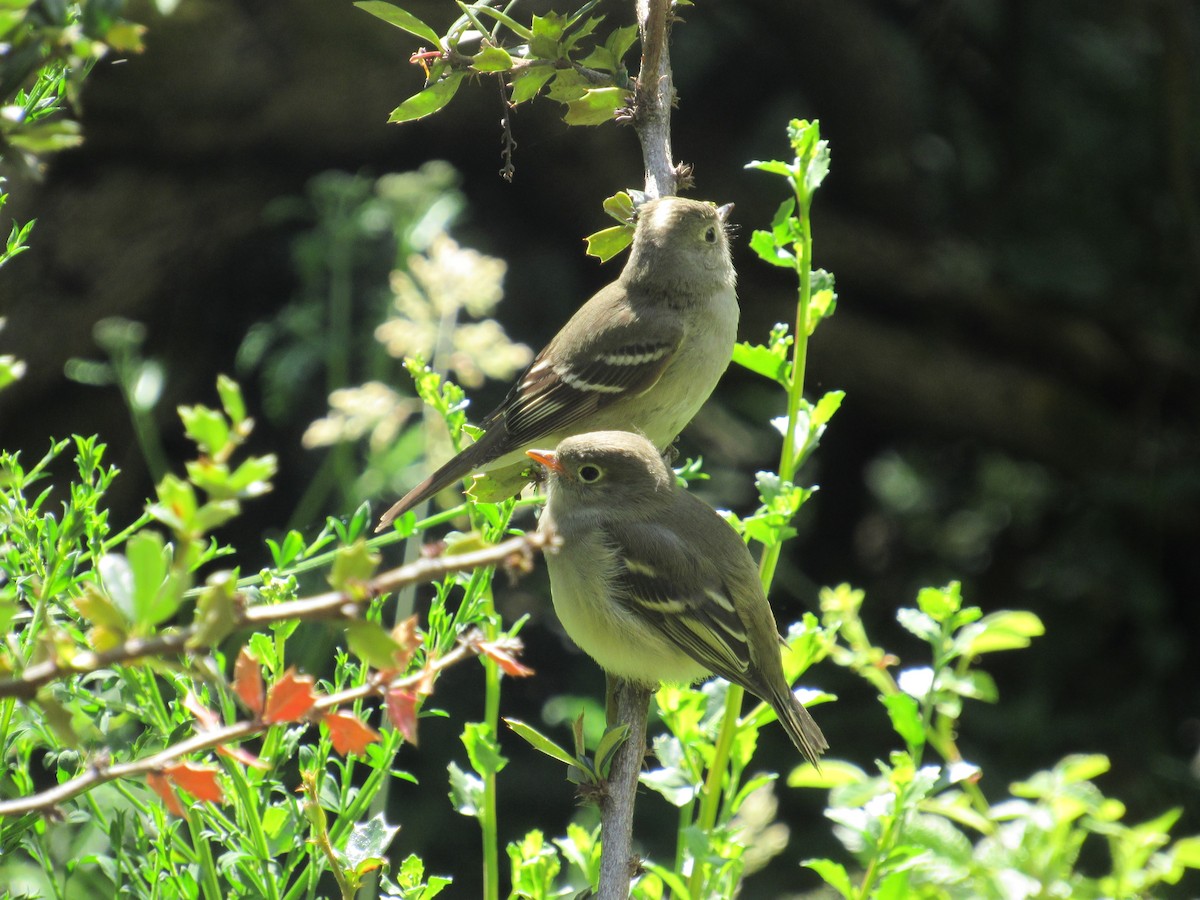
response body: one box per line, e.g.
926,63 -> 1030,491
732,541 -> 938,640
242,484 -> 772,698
0,0 -> 1200,895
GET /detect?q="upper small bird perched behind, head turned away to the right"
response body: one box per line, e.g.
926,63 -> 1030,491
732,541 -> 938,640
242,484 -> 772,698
376,197 -> 738,532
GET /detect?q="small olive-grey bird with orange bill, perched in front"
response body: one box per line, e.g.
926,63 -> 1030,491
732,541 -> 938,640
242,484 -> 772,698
527,431 -> 829,766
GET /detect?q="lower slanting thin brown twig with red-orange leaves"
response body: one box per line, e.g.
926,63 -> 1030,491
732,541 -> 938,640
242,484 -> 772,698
0,638 -> 496,818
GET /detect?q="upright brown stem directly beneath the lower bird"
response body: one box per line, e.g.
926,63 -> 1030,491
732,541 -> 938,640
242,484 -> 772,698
596,676 -> 652,900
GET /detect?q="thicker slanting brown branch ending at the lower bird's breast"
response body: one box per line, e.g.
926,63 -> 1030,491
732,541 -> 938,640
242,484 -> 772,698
0,532 -> 547,700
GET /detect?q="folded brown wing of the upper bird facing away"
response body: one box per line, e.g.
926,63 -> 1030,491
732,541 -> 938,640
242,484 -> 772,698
484,292 -> 683,449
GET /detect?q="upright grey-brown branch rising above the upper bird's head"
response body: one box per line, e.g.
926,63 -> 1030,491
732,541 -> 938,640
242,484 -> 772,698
634,0 -> 676,197
